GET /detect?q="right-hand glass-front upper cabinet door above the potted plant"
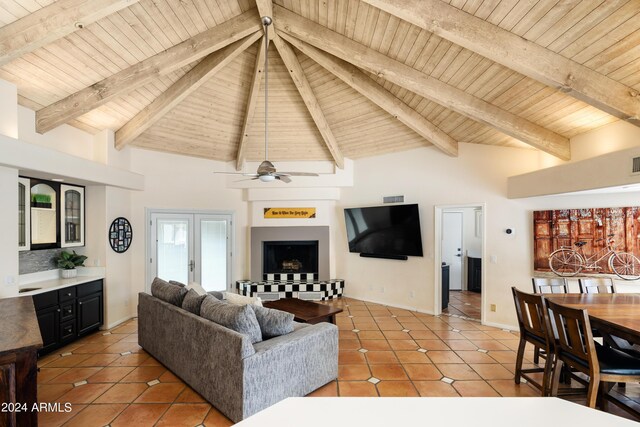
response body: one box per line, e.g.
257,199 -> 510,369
60,184 -> 84,248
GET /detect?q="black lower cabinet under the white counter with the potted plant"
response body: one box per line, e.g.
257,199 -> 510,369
33,280 -> 104,355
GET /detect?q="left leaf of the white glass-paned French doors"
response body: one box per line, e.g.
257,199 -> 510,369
152,214 -> 193,284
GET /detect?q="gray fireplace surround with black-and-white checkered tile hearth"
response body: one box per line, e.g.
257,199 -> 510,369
236,226 -> 344,300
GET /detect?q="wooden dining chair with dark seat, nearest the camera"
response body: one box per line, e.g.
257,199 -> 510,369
544,300 -> 640,417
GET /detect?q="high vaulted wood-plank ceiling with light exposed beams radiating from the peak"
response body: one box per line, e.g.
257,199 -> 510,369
0,0 -> 640,168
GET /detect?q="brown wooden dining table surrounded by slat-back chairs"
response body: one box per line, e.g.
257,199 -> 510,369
544,293 -> 640,345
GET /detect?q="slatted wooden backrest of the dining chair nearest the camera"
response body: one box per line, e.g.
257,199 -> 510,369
546,300 -> 600,371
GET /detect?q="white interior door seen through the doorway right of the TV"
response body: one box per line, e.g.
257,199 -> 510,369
441,212 -> 462,291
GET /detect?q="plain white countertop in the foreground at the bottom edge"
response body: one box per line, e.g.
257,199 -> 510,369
236,397 -> 638,427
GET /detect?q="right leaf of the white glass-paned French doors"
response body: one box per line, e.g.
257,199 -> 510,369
196,215 -> 230,291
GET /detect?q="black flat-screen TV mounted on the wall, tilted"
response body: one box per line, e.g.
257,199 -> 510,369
344,204 -> 422,259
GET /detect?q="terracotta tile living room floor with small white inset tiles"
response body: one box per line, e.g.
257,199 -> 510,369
38,298 -> 640,427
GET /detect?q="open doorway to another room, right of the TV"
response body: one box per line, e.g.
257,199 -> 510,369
434,204 -> 485,320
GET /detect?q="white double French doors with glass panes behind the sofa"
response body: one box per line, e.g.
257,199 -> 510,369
147,212 -> 232,291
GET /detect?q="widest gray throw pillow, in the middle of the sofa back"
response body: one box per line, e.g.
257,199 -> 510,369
200,295 -> 262,344
